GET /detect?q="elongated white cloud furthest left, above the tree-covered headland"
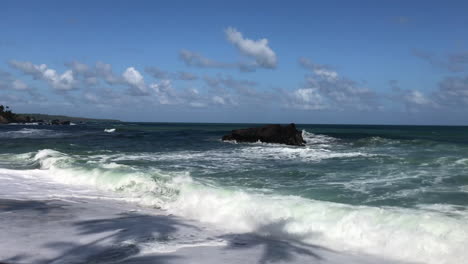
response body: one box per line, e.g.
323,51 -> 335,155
10,60 -> 75,91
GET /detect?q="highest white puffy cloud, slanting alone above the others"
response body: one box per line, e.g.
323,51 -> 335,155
225,27 -> 277,68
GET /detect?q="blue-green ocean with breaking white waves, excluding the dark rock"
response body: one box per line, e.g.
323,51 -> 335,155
0,122 -> 468,263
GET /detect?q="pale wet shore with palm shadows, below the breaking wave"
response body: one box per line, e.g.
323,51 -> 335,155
0,169 -> 402,264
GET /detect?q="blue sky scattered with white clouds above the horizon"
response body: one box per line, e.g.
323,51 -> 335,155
0,0 -> 468,125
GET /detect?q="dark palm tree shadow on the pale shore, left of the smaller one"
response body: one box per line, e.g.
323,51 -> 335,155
43,213 -> 197,264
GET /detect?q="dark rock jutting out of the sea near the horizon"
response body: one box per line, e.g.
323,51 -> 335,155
223,124 -> 306,146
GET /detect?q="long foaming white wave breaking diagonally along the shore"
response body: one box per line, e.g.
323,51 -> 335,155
1,149 -> 468,263
